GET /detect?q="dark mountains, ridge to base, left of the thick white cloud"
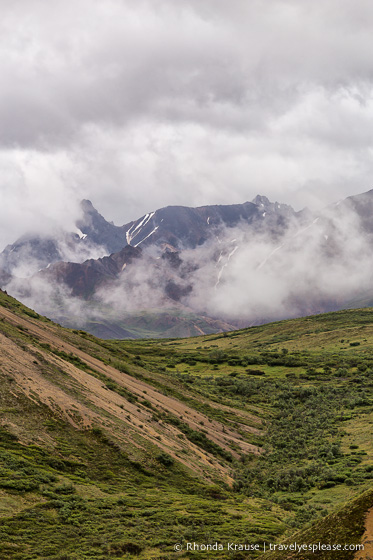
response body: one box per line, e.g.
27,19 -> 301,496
1,196 -> 304,337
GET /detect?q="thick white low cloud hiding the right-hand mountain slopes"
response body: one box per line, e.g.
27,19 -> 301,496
187,204 -> 373,326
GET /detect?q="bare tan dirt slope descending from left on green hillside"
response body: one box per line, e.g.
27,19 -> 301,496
0,300 -> 260,480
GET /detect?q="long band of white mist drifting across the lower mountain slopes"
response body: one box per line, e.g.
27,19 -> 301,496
7,196 -> 373,336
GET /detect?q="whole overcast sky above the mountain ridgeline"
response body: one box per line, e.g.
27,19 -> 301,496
0,0 -> 373,249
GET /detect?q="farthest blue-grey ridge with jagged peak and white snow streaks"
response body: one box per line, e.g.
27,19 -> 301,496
0,196 -> 301,276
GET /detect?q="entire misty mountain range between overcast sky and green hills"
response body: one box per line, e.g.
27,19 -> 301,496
0,191 -> 373,338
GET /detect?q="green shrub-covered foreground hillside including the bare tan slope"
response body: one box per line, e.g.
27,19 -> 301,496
0,292 -> 373,560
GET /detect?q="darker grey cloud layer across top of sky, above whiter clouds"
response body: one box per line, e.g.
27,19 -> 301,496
0,0 -> 373,147
